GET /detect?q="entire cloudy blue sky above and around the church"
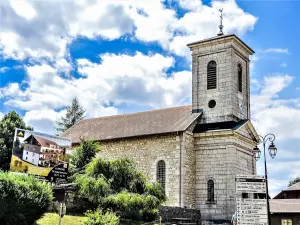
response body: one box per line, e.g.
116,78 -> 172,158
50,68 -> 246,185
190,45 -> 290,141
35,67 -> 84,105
0,0 -> 300,195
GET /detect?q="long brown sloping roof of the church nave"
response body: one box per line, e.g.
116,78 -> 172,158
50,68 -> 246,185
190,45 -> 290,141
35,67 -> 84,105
61,106 -> 202,143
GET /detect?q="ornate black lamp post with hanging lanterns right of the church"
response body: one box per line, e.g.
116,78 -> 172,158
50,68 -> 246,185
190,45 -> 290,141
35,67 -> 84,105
253,134 -> 277,225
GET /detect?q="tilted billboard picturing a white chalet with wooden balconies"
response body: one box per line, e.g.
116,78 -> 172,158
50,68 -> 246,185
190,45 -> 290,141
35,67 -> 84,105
10,128 -> 72,184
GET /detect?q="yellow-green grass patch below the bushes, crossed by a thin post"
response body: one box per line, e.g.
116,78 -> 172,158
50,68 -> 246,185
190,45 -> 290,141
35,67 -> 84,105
36,213 -> 85,225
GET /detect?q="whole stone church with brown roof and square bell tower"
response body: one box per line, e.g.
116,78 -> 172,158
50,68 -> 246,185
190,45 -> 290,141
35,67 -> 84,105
62,29 -> 259,220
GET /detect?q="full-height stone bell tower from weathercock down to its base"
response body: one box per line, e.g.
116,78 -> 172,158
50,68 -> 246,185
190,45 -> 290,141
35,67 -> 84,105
187,10 -> 259,221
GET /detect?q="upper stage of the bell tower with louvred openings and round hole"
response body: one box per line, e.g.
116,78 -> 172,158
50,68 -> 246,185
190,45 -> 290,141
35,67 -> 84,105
187,25 -> 254,124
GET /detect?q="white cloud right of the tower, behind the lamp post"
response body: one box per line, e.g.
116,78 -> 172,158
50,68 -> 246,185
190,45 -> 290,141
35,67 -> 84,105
251,74 -> 300,197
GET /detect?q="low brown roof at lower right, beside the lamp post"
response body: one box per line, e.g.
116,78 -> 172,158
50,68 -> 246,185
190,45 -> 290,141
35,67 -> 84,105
270,199 -> 300,213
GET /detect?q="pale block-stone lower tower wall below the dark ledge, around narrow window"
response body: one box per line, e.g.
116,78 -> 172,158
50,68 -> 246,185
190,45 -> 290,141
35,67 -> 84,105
194,130 -> 256,220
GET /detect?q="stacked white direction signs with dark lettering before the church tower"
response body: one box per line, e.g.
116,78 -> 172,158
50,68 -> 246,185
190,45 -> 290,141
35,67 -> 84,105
236,175 -> 268,225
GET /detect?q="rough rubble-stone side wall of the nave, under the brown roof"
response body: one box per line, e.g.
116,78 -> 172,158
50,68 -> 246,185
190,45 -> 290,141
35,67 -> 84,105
98,134 -> 180,206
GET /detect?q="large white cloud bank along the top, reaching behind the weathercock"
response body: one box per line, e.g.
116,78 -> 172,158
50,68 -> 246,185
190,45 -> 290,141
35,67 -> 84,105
0,0 -> 257,61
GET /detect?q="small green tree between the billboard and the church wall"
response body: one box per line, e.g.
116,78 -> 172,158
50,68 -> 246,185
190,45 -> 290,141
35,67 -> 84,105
69,139 -> 100,171
